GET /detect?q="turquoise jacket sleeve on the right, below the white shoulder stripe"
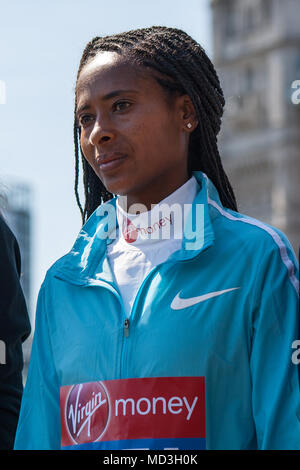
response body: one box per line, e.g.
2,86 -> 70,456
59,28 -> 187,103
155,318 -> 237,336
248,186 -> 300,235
250,234 -> 300,450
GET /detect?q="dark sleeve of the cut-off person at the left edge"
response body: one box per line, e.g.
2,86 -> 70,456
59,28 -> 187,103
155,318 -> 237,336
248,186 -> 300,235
0,216 -> 30,450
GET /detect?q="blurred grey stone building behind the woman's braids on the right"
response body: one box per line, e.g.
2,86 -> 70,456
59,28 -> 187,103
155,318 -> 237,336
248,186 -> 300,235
211,0 -> 300,251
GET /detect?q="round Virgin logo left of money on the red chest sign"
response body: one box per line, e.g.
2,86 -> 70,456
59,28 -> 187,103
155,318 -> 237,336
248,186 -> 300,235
65,382 -> 110,444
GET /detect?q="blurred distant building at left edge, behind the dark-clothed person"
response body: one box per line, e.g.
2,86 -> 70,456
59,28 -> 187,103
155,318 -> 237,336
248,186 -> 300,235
1,182 -> 32,378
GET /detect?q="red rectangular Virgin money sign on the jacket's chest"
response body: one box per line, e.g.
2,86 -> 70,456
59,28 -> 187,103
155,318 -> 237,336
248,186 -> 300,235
60,377 -> 205,449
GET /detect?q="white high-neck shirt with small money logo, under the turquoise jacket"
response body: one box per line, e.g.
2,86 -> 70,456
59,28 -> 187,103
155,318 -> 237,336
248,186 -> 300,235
107,176 -> 199,316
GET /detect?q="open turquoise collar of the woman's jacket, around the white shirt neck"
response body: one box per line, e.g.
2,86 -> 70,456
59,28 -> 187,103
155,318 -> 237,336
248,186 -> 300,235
53,171 -> 222,285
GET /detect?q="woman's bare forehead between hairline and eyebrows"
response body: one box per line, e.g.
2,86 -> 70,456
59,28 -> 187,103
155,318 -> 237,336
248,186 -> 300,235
76,52 -> 160,104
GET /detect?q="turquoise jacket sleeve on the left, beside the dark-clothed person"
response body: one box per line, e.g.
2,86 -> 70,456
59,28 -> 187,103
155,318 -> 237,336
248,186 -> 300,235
14,285 -> 60,450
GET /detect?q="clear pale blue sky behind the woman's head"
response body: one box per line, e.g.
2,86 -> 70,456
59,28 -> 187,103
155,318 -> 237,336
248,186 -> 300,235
0,0 -> 212,316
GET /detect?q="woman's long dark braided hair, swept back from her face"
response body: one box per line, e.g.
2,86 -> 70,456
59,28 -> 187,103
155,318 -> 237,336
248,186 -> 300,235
74,26 -> 237,223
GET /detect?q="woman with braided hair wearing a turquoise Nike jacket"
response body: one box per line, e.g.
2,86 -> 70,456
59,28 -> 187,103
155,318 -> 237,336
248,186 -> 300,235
15,26 -> 300,449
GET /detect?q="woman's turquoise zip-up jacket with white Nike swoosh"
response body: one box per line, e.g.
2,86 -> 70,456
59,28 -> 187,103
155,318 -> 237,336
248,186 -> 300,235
15,172 -> 300,449
